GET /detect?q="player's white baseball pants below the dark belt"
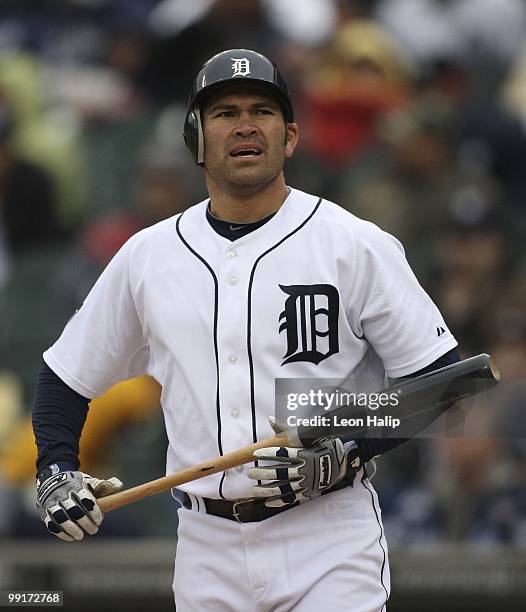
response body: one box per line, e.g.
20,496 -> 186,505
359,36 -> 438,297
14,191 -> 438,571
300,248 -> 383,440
174,479 -> 390,612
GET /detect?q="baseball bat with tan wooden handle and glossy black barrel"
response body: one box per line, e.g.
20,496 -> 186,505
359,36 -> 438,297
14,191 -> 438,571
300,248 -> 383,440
97,354 -> 500,512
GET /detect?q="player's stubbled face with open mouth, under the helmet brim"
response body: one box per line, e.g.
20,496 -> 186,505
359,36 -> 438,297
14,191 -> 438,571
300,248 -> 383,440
202,84 -> 298,192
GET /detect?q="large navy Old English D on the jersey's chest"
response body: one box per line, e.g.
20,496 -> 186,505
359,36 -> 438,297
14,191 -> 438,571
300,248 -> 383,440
279,285 -> 340,366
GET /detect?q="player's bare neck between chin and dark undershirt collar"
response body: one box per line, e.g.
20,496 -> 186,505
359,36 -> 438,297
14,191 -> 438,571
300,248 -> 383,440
208,177 -> 289,223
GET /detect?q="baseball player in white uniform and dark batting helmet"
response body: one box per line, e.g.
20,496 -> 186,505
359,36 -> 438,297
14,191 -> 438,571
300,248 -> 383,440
33,49 -> 458,612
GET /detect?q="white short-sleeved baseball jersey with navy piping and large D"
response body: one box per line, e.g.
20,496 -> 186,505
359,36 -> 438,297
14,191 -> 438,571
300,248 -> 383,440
44,189 -> 457,499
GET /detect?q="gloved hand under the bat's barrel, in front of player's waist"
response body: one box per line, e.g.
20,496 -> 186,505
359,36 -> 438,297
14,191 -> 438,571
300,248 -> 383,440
248,438 -> 361,508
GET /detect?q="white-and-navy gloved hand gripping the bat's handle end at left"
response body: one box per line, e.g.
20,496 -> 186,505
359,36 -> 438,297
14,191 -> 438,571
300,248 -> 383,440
37,467 -> 122,542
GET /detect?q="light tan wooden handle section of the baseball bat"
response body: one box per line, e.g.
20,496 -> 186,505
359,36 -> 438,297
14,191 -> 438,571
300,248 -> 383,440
97,433 -> 291,512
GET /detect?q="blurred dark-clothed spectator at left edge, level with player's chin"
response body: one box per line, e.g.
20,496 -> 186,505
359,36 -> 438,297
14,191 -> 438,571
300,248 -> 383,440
0,100 -> 60,253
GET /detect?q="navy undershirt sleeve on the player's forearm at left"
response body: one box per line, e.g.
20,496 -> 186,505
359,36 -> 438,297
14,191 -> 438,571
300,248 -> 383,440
33,363 -> 90,473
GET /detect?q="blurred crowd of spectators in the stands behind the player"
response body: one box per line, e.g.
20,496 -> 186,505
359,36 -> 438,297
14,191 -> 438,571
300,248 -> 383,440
0,0 -> 526,549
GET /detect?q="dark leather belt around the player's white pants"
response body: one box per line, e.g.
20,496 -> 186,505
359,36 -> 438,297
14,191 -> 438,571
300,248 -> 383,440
182,477 -> 352,523
